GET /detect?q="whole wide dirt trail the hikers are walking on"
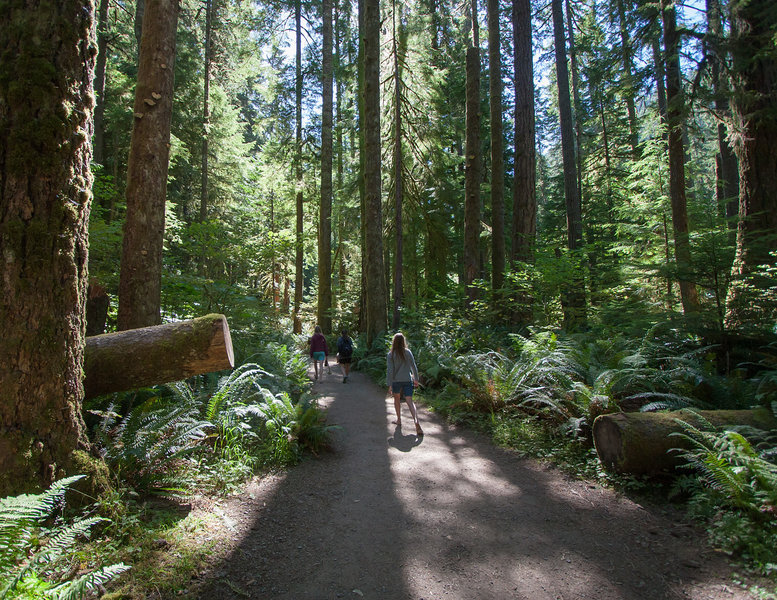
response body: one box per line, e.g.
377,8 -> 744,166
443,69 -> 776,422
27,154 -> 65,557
190,366 -> 750,600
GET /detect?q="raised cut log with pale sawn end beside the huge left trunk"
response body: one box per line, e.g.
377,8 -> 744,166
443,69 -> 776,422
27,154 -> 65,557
84,314 -> 235,398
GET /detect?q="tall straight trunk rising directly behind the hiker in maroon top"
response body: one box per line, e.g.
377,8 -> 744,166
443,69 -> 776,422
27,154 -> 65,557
318,0 -> 333,333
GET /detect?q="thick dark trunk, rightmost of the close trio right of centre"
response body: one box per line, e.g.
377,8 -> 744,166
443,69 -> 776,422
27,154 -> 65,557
512,0 -> 537,263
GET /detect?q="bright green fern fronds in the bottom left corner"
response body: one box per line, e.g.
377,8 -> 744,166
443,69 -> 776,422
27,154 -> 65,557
0,475 -> 129,600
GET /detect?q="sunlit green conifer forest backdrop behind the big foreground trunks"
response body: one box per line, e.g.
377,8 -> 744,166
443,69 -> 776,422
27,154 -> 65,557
82,0 -> 772,341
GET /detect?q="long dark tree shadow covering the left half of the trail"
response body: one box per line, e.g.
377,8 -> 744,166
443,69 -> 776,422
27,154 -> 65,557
199,370 -> 418,600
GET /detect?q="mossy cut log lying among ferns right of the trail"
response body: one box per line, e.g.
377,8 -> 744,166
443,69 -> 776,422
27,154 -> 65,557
593,408 -> 777,475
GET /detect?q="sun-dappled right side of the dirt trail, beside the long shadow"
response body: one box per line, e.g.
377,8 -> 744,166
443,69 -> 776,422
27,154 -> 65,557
395,396 -> 731,600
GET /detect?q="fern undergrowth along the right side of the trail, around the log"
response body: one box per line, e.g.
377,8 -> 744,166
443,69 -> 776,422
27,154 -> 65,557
404,324 -> 777,597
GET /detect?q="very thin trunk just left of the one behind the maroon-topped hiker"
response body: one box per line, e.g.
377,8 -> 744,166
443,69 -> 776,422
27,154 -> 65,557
293,0 -> 305,334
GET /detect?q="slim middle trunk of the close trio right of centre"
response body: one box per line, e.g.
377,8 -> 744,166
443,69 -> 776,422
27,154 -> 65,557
488,0 -> 505,302
